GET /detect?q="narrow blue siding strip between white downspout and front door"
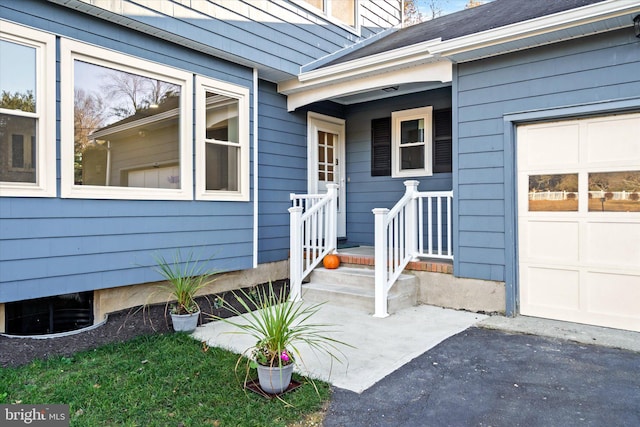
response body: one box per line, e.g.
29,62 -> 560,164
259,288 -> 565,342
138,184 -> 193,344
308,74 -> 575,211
258,81 -> 307,263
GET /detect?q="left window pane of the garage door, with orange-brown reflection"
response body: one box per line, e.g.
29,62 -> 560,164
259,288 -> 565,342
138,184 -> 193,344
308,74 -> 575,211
529,173 -> 578,212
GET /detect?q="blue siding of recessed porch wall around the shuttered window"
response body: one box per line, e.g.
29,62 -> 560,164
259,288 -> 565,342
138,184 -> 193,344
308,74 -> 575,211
346,87 -> 452,245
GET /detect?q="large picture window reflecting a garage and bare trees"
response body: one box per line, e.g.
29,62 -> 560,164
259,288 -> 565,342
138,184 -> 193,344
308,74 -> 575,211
60,39 -> 193,200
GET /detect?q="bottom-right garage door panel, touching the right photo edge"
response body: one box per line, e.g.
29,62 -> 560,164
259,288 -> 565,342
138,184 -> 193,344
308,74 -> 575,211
584,271 -> 640,320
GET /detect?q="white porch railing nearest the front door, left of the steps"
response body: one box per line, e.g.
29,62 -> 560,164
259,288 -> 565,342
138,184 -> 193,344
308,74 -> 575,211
289,184 -> 338,300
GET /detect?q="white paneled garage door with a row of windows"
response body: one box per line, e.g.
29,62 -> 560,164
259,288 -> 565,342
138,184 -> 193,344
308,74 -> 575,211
517,114 -> 640,331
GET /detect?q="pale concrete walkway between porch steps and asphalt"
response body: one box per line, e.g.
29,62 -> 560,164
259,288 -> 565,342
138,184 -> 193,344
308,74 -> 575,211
193,304 -> 487,393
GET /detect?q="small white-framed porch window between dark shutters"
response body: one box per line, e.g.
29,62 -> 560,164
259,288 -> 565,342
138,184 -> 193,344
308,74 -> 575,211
391,106 -> 433,178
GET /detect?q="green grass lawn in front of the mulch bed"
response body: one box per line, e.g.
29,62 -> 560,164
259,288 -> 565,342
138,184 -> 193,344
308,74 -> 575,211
0,334 -> 329,427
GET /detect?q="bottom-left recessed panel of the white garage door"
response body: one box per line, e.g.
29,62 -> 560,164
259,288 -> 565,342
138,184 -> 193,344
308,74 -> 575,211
522,266 -> 580,314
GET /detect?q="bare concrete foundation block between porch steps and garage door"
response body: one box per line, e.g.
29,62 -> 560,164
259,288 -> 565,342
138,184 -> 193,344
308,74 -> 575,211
411,271 -> 506,314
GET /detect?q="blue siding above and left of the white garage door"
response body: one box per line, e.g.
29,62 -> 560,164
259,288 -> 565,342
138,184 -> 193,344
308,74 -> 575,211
454,26 -> 640,290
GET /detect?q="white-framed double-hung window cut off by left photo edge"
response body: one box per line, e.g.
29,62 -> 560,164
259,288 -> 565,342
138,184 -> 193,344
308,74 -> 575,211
0,20 -> 56,197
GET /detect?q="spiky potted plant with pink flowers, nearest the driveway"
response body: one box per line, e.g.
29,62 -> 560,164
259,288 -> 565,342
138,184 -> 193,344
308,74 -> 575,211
210,283 -> 349,394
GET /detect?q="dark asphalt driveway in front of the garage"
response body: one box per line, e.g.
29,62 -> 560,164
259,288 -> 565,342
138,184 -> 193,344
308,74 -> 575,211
324,327 -> 640,427
